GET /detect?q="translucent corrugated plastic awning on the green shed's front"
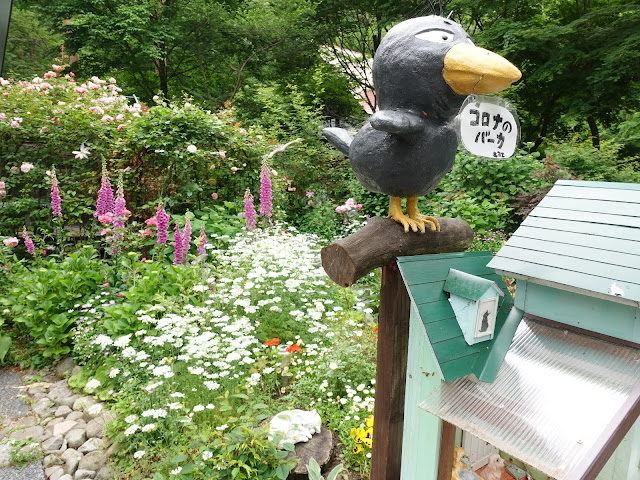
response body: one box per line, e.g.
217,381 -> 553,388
420,315 -> 640,480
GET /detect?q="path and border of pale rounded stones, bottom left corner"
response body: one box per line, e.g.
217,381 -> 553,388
0,359 -> 114,480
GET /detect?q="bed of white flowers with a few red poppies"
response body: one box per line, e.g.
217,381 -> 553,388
60,227 -> 375,479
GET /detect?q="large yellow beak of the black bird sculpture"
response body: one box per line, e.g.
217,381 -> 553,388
442,43 -> 522,95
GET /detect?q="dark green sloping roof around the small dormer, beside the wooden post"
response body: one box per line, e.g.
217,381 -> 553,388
398,252 -> 522,382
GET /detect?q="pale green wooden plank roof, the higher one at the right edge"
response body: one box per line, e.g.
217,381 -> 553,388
489,180 -> 640,306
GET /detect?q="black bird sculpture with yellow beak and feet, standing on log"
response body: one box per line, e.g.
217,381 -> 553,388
323,15 -> 521,233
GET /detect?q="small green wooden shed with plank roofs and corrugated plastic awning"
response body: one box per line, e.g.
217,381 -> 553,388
398,181 -> 640,480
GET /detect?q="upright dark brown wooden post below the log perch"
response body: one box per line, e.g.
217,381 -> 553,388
371,262 -> 411,480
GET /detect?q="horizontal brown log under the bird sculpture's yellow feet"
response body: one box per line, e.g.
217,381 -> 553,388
320,217 -> 474,287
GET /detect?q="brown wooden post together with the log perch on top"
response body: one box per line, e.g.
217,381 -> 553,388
321,217 -> 474,480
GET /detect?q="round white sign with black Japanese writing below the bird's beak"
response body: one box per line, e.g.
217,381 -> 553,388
458,95 -> 520,160
